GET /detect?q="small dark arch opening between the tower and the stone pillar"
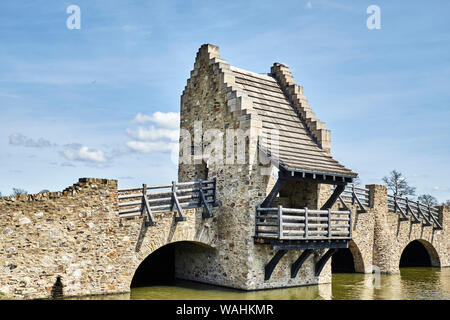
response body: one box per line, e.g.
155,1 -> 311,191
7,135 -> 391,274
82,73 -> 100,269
331,240 -> 365,273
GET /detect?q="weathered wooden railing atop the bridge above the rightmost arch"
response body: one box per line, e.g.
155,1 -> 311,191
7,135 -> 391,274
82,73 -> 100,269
388,194 -> 442,230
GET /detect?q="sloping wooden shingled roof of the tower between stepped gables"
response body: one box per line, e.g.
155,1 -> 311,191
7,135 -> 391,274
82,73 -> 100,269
230,66 -> 357,178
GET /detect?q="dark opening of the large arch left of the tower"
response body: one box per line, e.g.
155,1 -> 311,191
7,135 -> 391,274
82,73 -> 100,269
130,241 -> 214,288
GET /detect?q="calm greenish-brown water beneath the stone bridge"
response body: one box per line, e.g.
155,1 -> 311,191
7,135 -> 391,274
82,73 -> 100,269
76,268 -> 450,300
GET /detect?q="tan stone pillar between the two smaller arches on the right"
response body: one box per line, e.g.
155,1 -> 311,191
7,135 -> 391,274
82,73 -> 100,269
366,185 -> 400,273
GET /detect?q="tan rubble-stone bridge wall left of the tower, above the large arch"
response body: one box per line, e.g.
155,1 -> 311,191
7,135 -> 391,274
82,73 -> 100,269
0,178 -> 214,299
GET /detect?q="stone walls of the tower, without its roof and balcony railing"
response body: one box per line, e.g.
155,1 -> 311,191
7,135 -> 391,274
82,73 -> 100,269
177,45 -> 330,290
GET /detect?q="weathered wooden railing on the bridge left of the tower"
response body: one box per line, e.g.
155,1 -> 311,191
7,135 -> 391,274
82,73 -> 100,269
118,179 -> 216,225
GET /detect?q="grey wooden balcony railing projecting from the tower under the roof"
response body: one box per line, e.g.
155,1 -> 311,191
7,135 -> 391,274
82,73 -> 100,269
255,206 -> 352,240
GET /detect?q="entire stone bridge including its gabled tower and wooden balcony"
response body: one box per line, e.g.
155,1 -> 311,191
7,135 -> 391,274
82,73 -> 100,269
0,44 -> 450,299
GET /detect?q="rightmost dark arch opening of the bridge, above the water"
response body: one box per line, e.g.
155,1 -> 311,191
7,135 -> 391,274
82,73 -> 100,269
397,239 -> 441,267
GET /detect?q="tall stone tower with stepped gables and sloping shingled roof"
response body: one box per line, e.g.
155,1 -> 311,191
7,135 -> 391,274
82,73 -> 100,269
176,44 -> 356,290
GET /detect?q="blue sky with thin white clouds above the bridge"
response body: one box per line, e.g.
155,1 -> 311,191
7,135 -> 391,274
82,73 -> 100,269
0,0 -> 450,201
